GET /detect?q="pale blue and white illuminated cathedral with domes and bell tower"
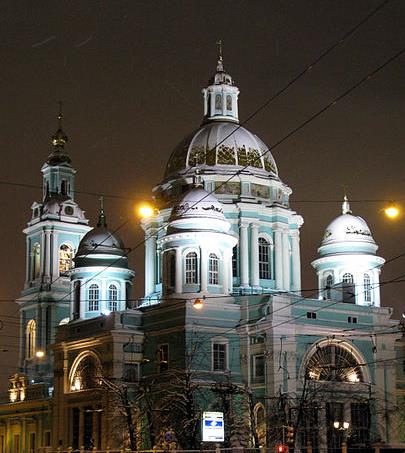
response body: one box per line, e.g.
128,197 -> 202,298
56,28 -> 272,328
0,56 -> 405,453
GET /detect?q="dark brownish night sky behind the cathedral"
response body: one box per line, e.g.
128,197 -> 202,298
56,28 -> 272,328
0,0 -> 405,387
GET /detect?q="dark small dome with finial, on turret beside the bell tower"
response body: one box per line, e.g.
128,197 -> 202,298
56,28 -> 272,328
74,209 -> 128,268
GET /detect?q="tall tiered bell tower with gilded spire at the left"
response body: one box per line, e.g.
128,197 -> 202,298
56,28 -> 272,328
16,110 -> 90,381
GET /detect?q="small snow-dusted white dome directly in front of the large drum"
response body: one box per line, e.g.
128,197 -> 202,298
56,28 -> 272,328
170,186 -> 226,221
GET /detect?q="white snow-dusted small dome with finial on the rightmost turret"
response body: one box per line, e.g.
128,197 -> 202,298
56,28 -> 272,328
320,197 -> 377,253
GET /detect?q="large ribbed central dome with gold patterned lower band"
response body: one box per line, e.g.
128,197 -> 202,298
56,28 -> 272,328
165,121 -> 278,179
